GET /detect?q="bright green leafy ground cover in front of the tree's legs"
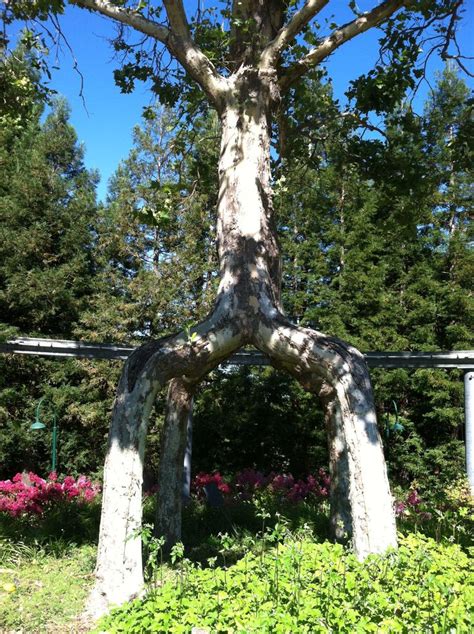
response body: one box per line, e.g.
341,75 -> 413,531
97,535 -> 474,634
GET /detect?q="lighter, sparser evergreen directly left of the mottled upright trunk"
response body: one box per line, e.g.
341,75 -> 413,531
78,109 -> 216,341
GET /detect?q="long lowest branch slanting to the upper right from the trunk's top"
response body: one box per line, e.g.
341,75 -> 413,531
280,0 -> 406,92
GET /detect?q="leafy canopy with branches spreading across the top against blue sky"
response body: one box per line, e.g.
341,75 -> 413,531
3,0 -> 470,112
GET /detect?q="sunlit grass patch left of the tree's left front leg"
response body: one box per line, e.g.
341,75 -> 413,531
0,540 -> 96,634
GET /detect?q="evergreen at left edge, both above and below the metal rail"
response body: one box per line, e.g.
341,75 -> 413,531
0,84 -> 115,477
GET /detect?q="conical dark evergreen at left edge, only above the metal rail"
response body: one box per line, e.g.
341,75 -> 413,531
0,101 -> 96,337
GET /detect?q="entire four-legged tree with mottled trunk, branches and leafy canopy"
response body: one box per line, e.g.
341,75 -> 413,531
4,0 -> 470,613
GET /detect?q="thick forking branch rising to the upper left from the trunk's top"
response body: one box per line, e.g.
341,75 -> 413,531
71,0 -> 227,109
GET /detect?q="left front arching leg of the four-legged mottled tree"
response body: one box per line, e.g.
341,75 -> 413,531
85,318 -> 242,619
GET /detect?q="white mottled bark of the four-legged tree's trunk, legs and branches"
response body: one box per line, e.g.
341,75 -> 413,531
83,0 -> 403,616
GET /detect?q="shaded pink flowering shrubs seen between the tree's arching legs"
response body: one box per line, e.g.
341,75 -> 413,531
193,469 -> 330,503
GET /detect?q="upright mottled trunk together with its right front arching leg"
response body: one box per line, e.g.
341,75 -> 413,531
155,69 -> 397,559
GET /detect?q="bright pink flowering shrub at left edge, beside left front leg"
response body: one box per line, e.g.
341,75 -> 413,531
0,472 -> 100,517
